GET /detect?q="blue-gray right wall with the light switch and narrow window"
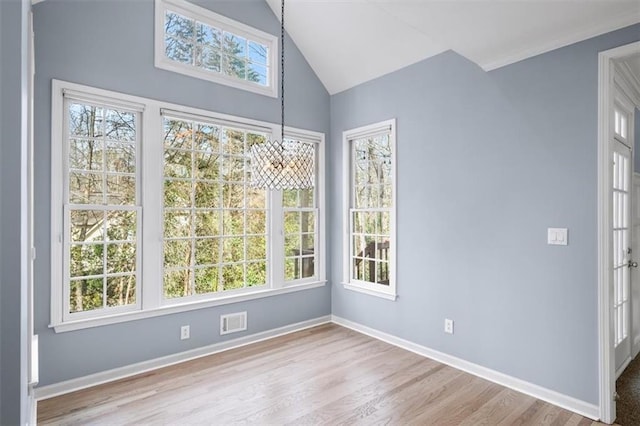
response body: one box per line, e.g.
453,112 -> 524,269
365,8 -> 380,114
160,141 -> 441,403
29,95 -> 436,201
328,25 -> 640,404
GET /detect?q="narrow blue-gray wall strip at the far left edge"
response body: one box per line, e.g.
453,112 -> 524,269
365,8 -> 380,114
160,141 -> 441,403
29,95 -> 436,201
0,0 -> 29,425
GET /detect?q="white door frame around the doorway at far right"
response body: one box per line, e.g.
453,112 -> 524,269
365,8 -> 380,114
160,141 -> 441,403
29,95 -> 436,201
597,41 -> 640,423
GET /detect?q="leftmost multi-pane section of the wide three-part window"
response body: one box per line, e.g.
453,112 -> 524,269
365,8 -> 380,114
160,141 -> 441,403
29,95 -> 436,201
63,98 -> 140,318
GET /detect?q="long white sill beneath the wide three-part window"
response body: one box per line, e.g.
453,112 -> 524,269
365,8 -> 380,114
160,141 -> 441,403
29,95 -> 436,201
49,281 -> 327,333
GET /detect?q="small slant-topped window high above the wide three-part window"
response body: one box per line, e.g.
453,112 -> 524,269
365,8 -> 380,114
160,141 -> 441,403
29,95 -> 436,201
156,0 -> 277,96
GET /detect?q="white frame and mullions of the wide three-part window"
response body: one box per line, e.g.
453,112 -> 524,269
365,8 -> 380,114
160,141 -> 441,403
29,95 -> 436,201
50,80 -> 326,332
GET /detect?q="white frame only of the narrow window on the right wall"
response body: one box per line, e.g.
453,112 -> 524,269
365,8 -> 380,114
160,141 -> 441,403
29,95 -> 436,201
342,119 -> 397,300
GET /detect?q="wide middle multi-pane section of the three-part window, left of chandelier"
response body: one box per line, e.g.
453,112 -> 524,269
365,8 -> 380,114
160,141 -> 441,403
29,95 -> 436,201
163,116 -> 268,299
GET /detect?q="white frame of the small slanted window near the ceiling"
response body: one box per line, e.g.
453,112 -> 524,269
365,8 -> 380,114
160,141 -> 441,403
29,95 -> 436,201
154,0 -> 279,98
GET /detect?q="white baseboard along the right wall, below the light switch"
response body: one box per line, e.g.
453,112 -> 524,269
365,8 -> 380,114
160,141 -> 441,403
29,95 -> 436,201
331,315 -> 600,420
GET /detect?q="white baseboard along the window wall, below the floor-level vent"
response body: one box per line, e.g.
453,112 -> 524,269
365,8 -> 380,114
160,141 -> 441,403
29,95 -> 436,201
35,315 -> 331,400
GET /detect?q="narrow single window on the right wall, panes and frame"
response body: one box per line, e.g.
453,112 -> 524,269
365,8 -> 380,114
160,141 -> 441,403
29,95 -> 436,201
343,119 -> 396,300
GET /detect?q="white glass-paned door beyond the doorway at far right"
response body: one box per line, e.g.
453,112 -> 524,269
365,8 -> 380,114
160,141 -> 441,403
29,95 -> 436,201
612,138 -> 634,375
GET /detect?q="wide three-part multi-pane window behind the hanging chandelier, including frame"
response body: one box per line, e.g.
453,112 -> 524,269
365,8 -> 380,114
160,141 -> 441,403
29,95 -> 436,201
51,80 -> 324,331
